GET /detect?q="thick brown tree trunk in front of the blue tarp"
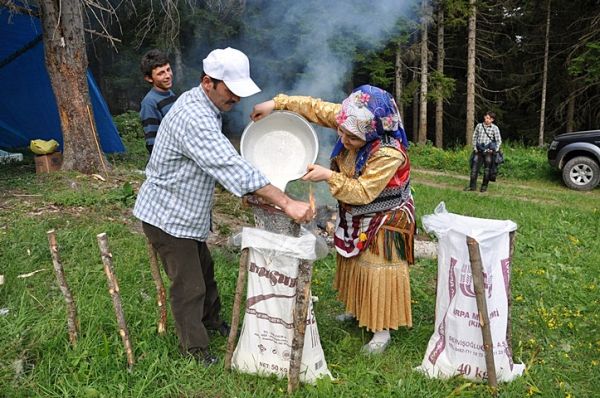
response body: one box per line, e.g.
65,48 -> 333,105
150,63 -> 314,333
38,0 -> 106,174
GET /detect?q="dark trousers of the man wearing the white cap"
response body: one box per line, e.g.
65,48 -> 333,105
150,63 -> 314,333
142,223 -> 222,353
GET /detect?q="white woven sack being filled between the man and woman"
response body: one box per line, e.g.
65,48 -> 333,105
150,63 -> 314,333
232,228 -> 331,383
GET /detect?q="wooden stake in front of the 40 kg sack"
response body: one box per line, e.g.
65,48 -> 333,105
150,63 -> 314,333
467,236 -> 498,396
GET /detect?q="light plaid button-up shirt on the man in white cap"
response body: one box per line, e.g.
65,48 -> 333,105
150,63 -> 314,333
133,87 -> 269,241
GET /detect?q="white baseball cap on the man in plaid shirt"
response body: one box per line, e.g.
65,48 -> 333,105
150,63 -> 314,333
202,47 -> 260,97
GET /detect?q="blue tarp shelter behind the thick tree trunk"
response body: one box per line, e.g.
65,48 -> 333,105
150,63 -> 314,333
0,5 -> 125,153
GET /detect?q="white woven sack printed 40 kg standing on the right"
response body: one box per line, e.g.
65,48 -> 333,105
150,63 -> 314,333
417,202 -> 525,382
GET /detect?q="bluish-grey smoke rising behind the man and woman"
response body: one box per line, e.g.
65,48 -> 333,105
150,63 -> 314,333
196,0 -> 416,202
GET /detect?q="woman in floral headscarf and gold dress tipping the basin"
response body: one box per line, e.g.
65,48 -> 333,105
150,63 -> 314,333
251,85 -> 415,354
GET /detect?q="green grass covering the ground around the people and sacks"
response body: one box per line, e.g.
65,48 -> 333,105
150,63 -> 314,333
0,137 -> 600,397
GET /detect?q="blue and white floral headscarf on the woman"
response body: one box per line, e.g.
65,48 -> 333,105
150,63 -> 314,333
331,84 -> 408,175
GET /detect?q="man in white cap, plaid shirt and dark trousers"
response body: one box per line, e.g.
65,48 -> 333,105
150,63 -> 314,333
133,47 -> 313,366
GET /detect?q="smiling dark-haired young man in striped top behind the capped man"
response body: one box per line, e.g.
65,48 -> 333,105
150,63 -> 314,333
140,49 -> 177,154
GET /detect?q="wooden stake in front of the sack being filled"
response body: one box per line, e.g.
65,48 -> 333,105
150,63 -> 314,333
288,260 -> 312,394
